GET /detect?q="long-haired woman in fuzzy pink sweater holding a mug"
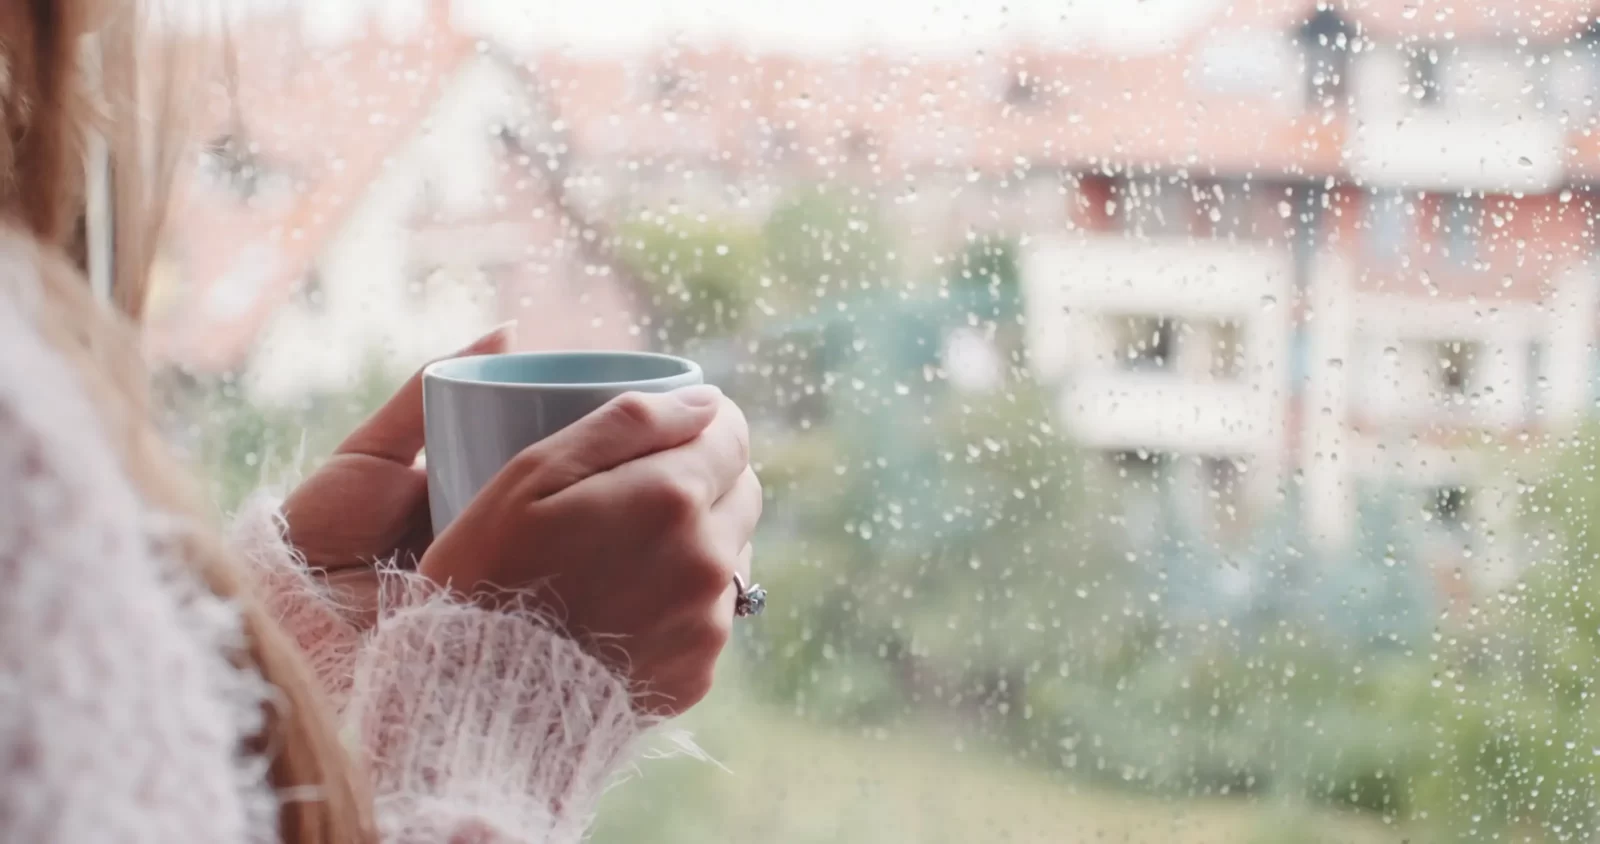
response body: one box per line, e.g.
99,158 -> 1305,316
0,0 -> 760,844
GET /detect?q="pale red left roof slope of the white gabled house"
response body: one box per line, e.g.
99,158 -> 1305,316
157,3 -> 475,368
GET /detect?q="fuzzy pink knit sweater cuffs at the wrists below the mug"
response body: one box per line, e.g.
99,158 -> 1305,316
235,504 -> 648,844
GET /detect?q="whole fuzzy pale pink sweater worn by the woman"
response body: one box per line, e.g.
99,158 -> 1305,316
0,286 -> 645,844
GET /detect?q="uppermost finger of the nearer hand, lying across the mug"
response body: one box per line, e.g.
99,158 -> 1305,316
523,384 -> 726,499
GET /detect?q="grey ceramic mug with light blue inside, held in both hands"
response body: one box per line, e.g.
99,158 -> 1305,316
422,352 -> 704,534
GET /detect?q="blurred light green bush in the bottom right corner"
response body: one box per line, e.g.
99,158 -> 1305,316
1397,428 -> 1600,842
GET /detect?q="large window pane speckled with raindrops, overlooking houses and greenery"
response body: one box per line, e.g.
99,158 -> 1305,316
147,0 -> 1600,844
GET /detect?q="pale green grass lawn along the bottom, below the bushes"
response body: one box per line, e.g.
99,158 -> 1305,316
594,707 -> 1405,844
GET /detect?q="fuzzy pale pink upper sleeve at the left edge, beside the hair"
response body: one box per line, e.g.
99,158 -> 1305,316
0,295 -> 277,844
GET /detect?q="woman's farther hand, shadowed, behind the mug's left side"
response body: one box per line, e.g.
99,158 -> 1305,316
283,326 -> 507,574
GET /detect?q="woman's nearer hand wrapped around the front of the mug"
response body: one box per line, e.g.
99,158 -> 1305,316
421,387 -> 762,715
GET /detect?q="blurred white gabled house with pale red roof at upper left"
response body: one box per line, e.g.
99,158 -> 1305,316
155,5 -> 643,401
